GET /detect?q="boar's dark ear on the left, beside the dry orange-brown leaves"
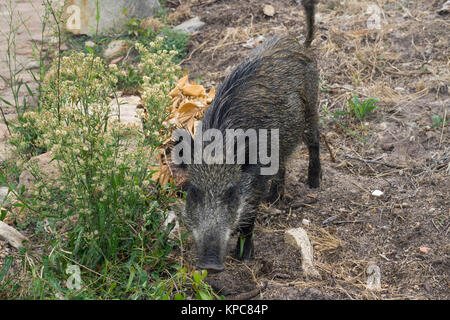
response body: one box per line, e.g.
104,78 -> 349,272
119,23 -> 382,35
170,129 -> 194,171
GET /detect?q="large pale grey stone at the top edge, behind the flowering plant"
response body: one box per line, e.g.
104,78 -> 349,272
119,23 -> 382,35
63,0 -> 161,36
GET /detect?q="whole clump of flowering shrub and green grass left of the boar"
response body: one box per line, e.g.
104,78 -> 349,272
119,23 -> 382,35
0,2 -> 211,299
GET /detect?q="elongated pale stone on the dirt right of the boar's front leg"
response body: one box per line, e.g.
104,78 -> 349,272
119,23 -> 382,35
284,228 -> 321,279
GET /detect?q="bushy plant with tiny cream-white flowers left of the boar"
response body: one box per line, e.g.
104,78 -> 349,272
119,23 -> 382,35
14,47 -> 179,266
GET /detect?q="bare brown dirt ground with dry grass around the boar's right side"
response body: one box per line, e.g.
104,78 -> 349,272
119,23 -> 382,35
167,0 -> 450,299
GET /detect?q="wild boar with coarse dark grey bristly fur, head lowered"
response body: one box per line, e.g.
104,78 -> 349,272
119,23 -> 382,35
178,0 -> 320,270
